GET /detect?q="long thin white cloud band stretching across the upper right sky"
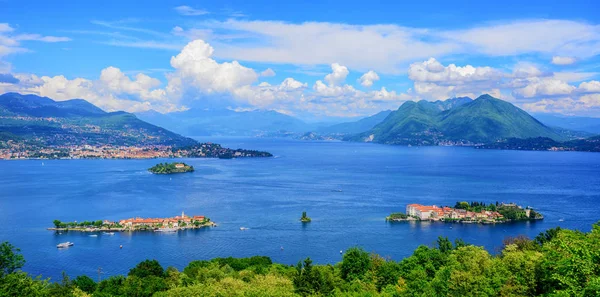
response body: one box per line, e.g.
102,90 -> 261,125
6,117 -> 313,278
171,19 -> 600,74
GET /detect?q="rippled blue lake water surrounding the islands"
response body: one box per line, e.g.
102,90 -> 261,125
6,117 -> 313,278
0,138 -> 600,279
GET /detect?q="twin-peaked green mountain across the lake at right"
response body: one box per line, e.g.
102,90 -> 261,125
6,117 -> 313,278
350,95 -> 564,145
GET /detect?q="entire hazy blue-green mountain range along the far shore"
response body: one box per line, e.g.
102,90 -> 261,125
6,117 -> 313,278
0,93 -> 596,146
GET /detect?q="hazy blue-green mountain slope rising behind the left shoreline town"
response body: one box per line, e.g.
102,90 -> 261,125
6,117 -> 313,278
0,93 -> 197,146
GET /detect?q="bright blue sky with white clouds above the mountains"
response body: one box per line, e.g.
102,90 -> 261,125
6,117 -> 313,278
0,0 -> 600,120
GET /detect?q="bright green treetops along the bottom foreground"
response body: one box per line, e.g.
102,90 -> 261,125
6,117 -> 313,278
5,221 -> 600,297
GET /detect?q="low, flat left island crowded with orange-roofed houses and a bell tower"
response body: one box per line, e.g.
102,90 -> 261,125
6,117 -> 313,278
48,212 -> 217,232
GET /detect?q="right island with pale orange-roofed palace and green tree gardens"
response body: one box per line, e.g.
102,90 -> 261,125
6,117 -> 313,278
386,201 -> 544,224
